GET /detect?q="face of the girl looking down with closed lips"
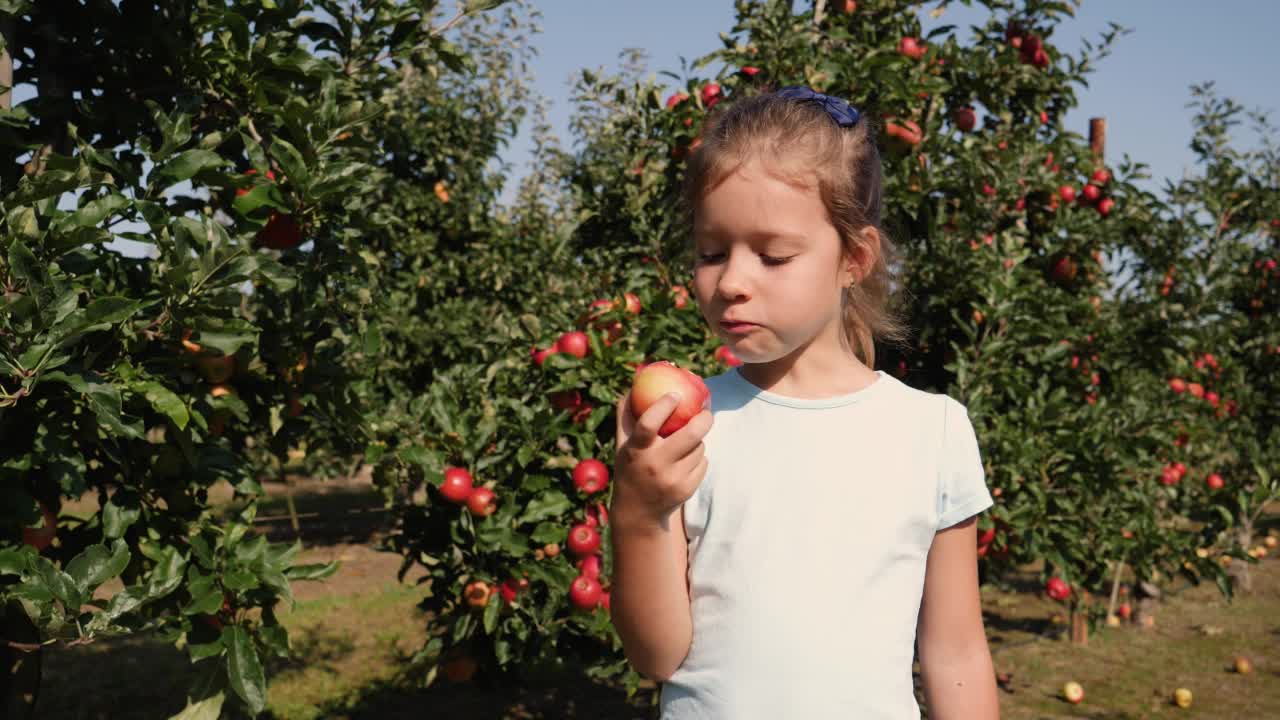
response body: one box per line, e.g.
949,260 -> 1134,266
692,163 -> 852,364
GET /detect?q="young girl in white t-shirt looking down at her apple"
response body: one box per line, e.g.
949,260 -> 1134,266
611,87 -> 998,720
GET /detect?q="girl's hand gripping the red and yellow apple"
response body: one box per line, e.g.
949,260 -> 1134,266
612,391 -> 712,528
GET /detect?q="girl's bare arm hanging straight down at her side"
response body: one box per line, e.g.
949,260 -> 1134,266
916,516 -> 1000,720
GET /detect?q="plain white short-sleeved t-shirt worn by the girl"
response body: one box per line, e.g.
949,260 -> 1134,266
660,368 -> 992,720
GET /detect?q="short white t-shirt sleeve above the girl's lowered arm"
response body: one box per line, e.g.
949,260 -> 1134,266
938,395 -> 995,530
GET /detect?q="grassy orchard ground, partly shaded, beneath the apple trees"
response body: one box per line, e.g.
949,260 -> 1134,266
37,483 -> 1280,720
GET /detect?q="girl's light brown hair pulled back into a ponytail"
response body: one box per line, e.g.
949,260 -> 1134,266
680,92 -> 910,369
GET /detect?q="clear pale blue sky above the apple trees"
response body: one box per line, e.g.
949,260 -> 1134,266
500,0 -> 1280,200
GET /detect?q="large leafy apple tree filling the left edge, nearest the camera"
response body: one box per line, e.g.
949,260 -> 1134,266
0,0 -> 514,717
